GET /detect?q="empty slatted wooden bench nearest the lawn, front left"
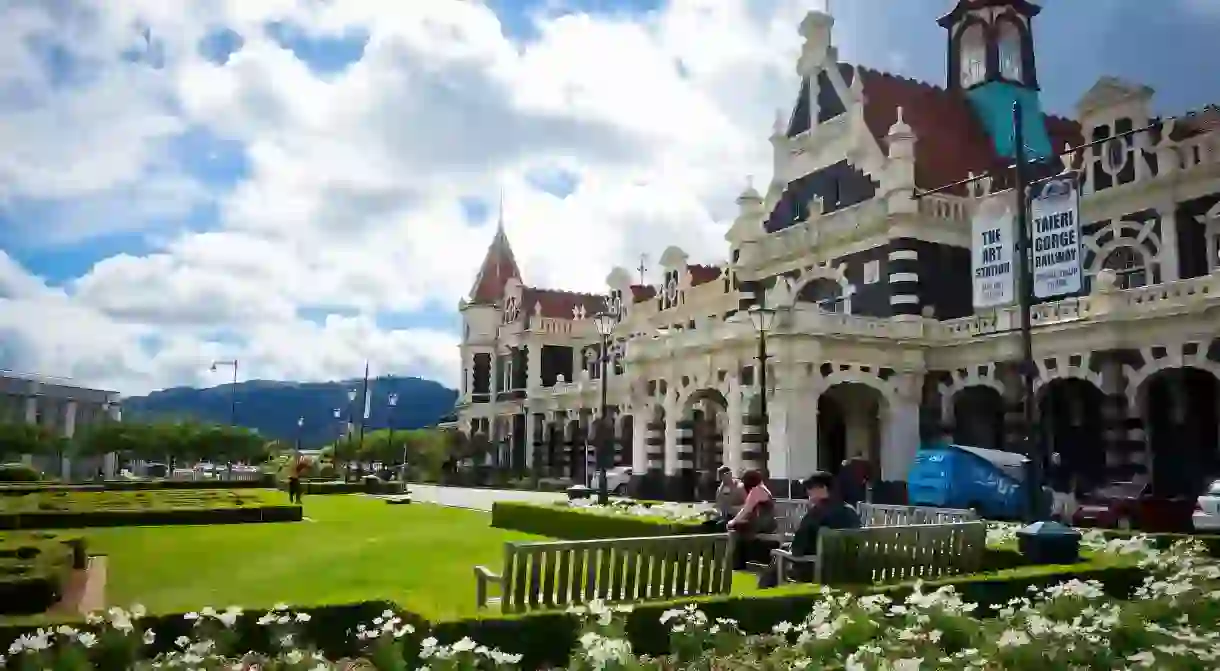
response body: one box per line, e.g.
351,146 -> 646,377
475,533 -> 733,614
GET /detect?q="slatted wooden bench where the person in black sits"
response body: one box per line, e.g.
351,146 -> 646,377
771,520 -> 987,584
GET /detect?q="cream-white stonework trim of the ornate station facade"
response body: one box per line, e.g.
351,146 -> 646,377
458,3 -> 1220,500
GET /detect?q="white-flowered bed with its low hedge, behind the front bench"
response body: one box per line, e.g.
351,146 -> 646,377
492,500 -> 705,540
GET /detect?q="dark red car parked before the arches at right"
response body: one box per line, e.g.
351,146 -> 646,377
1072,482 -> 1194,532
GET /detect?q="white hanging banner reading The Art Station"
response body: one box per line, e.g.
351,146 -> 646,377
970,194 -> 1016,307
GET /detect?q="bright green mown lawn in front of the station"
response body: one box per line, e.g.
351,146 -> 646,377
69,495 -> 754,620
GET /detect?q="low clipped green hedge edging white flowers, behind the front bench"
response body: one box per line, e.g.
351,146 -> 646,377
492,501 -> 702,540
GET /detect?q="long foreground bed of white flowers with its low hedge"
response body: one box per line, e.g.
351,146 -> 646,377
0,543 -> 1220,671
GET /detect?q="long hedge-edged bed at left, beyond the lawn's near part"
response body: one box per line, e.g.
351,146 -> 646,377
0,489 -> 301,529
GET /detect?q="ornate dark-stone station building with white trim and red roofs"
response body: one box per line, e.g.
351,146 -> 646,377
458,0 -> 1220,498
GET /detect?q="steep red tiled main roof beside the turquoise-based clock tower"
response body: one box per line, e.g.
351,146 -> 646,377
855,67 -> 1082,194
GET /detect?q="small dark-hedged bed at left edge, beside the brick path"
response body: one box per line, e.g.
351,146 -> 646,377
0,532 -> 87,615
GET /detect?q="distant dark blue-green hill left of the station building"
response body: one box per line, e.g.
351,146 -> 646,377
123,377 -> 458,448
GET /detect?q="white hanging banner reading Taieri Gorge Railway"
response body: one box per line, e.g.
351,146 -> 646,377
1030,174 -> 1083,298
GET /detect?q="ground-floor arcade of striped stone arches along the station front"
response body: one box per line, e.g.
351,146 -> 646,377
509,362 -> 1220,499
